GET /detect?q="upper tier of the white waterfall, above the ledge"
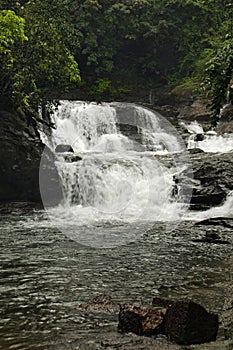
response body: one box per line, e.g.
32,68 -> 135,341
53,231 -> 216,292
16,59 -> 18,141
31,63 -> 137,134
45,100 -> 183,153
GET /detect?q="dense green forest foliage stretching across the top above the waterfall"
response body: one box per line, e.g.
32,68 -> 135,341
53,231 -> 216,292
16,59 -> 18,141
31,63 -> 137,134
0,0 -> 233,123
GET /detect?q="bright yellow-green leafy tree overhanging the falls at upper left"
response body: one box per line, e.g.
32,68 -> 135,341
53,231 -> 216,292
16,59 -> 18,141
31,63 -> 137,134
0,1 -> 80,126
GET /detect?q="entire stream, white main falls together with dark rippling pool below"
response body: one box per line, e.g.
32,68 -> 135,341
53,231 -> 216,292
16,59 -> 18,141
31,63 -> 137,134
0,101 -> 232,350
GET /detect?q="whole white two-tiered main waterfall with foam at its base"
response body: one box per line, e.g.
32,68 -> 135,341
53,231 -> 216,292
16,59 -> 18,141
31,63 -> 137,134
40,101 -> 193,246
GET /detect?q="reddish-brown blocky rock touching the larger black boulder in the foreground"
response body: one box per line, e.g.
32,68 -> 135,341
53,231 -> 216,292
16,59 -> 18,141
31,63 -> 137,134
118,304 -> 166,336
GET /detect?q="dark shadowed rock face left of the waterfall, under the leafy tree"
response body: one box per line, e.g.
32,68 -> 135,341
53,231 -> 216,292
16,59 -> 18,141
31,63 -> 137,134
0,111 -> 62,202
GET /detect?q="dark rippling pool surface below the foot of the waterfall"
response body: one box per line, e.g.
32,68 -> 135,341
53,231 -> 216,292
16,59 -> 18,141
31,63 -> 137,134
0,211 -> 231,350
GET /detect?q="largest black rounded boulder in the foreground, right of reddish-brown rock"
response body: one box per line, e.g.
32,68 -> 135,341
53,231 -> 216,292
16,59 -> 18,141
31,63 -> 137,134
164,300 -> 218,345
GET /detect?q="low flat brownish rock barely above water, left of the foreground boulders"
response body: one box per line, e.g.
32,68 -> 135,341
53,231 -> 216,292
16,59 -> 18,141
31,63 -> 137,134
79,294 -> 120,312
